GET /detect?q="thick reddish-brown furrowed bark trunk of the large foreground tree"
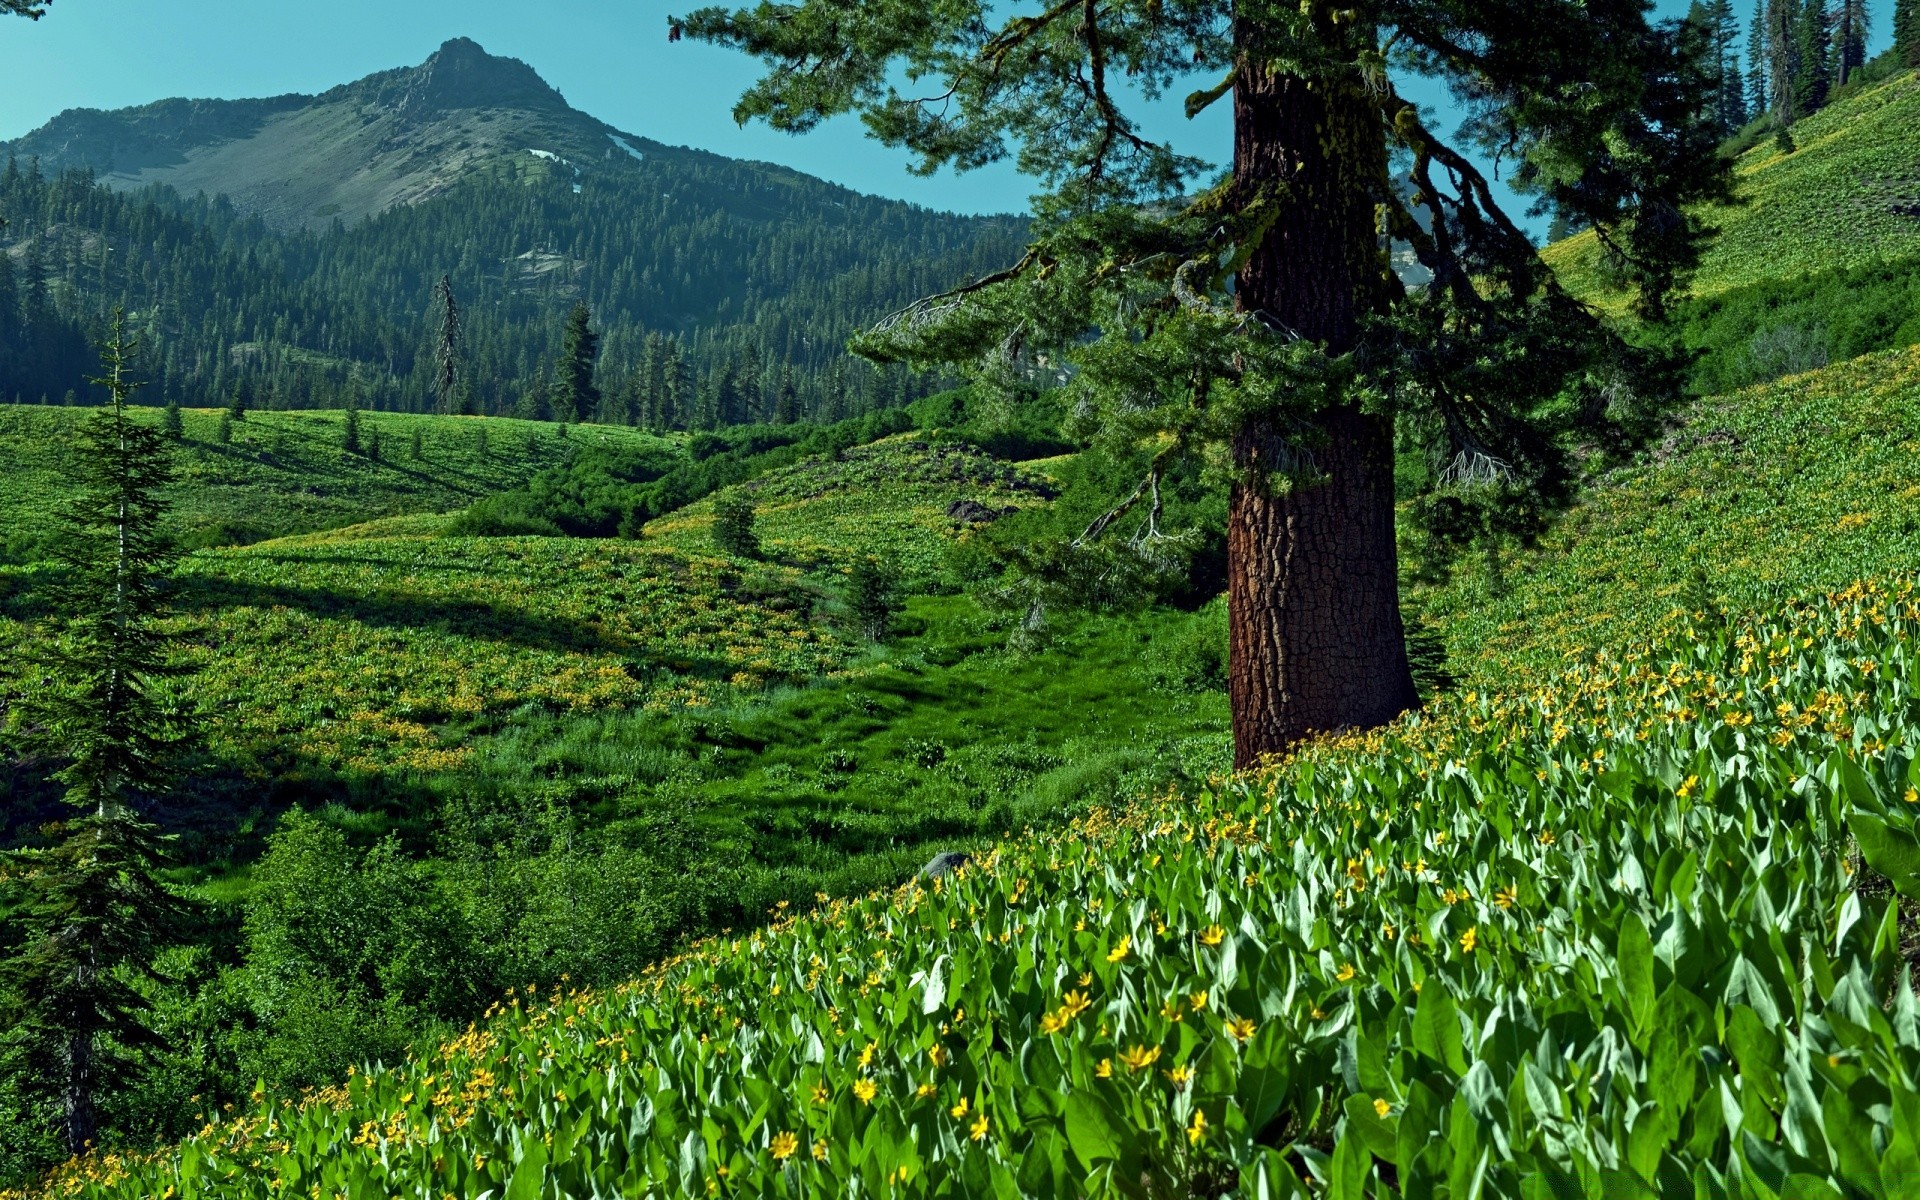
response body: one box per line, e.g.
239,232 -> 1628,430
1227,65 -> 1417,768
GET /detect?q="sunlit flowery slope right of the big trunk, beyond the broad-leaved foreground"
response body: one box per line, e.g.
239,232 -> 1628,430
1407,349 -> 1920,682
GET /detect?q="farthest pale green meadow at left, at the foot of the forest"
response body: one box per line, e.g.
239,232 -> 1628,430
0,405 -> 659,561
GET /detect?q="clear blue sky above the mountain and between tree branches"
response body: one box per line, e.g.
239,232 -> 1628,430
0,0 -> 1889,224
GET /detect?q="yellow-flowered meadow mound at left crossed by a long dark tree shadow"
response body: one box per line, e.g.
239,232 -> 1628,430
167,530 -> 851,772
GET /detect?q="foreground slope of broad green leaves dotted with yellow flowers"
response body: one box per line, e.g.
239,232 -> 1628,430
30,582 -> 1920,1200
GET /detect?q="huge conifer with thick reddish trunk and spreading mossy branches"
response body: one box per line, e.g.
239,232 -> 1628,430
670,0 -> 1730,766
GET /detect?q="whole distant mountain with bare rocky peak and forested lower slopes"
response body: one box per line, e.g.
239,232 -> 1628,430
0,40 -> 1025,416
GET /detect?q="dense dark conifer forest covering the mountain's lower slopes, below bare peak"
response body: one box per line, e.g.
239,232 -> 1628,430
0,156 -> 1025,418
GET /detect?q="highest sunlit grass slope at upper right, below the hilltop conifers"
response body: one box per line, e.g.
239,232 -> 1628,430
1546,71 -> 1920,303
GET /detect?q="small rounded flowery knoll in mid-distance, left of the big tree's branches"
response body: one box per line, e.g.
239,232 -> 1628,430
647,434 -> 1050,584
